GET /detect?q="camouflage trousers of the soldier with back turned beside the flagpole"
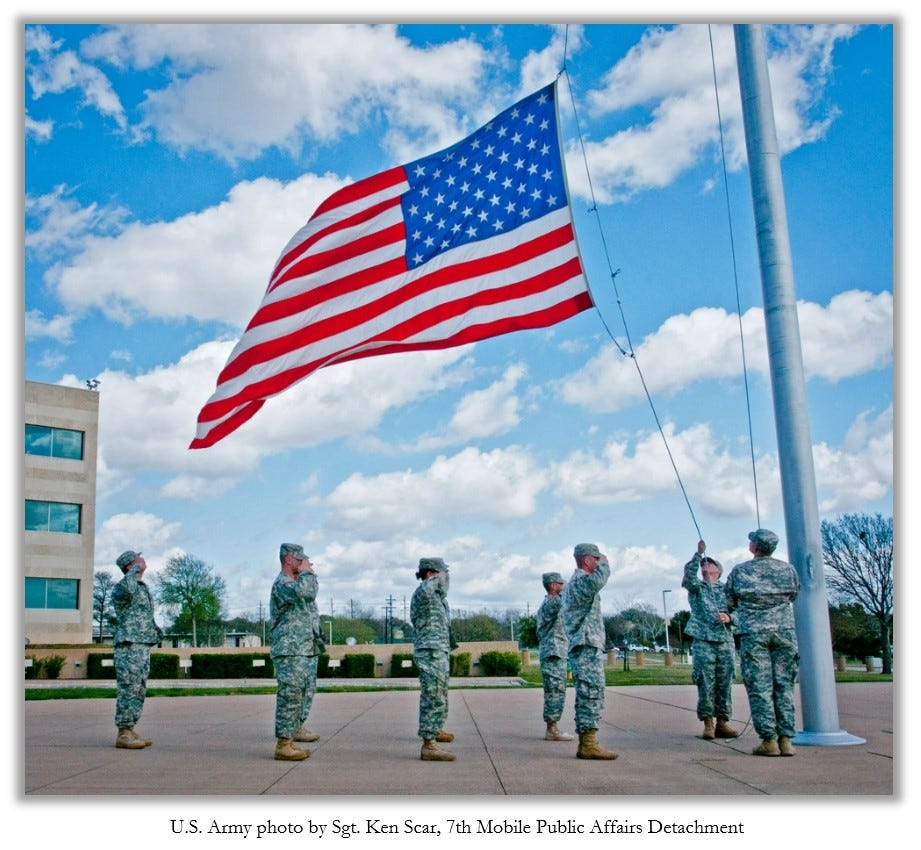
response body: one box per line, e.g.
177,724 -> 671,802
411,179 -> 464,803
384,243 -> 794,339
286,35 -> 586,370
741,629 -> 799,739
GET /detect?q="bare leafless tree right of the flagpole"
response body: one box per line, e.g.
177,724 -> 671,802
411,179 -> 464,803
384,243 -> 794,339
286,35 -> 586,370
822,514 -> 894,673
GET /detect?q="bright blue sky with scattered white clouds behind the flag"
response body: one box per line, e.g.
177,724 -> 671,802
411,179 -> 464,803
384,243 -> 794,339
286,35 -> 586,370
23,23 -> 894,628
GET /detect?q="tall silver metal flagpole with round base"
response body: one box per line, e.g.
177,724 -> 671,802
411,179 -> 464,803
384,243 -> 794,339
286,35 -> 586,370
733,24 -> 866,746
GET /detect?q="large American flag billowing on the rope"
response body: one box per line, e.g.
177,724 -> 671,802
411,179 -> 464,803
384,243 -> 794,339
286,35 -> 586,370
190,83 -> 592,449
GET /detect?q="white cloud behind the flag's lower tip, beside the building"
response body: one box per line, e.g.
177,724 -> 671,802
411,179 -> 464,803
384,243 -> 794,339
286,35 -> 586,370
76,342 -> 469,499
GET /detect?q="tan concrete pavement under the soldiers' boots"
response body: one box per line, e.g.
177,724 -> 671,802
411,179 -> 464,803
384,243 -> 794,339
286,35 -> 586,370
22,679 -> 896,799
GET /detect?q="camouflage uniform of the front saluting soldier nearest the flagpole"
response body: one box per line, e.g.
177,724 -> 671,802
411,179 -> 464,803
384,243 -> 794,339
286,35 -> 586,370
562,561 -> 611,733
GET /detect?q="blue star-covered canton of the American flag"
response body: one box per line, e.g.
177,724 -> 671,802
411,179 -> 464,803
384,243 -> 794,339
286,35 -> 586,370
402,84 -> 567,269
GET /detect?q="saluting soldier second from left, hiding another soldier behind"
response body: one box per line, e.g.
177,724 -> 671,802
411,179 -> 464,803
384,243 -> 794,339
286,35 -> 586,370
269,543 -> 325,761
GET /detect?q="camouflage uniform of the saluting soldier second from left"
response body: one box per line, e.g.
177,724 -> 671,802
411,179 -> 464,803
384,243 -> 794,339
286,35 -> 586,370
269,570 -> 324,738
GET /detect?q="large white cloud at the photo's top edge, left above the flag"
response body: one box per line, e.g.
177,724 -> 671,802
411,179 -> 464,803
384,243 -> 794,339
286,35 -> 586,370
81,23 -> 493,162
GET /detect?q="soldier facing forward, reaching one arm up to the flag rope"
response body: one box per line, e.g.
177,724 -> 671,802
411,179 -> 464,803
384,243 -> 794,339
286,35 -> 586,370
681,540 -> 739,741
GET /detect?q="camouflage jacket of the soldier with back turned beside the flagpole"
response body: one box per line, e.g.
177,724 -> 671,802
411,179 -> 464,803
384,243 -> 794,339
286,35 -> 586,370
726,557 -> 799,635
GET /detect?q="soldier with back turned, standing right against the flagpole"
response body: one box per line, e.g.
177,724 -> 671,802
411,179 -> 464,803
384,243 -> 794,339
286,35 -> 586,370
726,528 -> 799,756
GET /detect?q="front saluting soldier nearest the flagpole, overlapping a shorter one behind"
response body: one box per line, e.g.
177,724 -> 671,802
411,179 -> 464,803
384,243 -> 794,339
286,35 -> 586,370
563,543 -> 617,759
